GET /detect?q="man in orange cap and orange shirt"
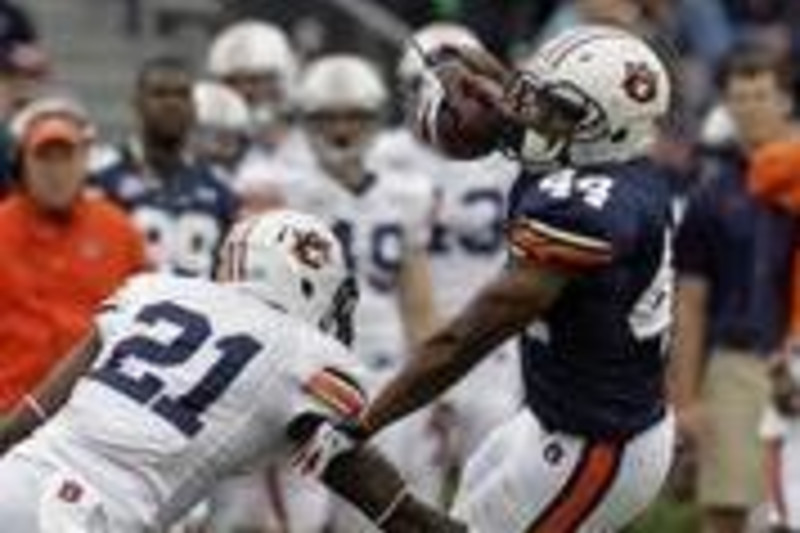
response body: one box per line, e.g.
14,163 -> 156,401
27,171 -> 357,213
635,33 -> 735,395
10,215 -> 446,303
0,98 -> 144,417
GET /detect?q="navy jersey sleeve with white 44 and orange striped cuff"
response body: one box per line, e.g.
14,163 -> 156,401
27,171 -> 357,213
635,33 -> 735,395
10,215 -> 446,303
507,172 -> 637,273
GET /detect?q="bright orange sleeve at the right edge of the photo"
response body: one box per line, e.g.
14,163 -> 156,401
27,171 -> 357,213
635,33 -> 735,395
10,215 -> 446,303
747,140 -> 800,213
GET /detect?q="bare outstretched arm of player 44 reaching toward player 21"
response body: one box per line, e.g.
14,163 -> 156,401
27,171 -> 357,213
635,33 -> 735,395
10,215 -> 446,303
362,264 -> 568,433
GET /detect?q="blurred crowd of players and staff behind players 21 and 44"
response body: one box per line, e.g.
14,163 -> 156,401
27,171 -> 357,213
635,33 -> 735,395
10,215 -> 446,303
0,0 -> 800,533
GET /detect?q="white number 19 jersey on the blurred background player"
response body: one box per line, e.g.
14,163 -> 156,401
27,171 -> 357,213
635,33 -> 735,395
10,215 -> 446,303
239,135 -> 434,366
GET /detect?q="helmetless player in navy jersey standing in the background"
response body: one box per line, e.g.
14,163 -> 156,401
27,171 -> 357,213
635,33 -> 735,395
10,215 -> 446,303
93,57 -> 238,277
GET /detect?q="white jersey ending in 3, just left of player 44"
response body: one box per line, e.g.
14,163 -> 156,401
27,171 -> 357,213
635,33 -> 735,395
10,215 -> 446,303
372,129 -> 519,316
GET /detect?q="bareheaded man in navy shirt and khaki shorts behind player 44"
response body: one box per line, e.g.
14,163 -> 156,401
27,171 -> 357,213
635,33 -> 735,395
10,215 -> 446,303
670,49 -> 796,533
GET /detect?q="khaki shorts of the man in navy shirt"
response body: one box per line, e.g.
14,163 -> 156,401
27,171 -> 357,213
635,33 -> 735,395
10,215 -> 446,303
698,350 -> 770,508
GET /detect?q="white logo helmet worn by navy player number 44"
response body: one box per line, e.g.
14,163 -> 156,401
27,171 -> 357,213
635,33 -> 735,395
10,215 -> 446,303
520,25 -> 672,165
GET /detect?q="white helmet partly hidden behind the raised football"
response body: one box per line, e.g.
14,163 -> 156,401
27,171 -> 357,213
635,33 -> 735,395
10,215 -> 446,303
397,22 -> 483,84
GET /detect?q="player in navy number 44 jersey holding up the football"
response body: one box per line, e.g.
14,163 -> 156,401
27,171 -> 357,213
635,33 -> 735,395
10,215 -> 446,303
326,26 -> 674,533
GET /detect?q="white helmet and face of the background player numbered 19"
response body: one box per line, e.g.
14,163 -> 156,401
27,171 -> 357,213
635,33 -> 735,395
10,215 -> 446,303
297,54 -> 388,169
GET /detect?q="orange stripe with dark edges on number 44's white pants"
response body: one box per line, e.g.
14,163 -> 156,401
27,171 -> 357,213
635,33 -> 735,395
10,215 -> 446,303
528,442 -> 624,533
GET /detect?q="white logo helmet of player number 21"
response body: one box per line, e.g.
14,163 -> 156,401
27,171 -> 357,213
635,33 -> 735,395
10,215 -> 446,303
217,209 -> 357,343
